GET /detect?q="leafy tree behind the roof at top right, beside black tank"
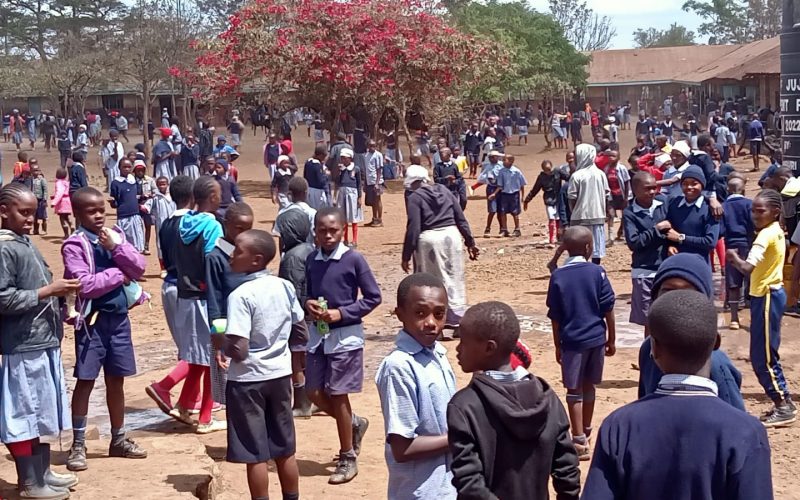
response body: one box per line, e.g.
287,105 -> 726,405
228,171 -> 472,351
683,0 -> 782,45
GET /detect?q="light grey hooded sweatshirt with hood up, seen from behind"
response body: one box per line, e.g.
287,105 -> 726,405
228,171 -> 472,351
567,144 -> 609,226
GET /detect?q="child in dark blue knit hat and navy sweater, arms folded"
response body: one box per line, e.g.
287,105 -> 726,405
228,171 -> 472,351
665,165 -> 719,265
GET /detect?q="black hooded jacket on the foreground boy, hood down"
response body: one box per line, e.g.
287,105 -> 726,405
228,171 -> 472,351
447,369 -> 580,500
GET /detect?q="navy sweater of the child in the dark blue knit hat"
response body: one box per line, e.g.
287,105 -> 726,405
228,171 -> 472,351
667,196 -> 719,260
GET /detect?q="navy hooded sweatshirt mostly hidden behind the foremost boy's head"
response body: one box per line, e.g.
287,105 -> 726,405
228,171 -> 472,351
639,253 -> 745,411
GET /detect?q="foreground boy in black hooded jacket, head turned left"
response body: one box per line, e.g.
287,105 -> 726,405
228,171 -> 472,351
447,302 -> 580,500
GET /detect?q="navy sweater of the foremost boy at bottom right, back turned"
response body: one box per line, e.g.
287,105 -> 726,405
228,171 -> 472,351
582,389 -> 773,500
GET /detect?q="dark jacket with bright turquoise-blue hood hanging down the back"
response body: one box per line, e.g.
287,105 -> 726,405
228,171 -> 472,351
175,210 -> 222,299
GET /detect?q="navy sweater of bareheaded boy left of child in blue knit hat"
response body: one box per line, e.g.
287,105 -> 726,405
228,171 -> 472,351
622,196 -> 668,272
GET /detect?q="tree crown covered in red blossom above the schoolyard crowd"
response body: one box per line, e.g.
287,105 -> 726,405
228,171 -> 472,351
174,0 -> 502,145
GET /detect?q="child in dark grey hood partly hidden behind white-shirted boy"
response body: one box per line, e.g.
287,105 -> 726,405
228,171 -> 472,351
275,210 -> 314,418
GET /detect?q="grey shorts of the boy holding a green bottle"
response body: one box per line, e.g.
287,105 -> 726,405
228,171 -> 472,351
306,346 -> 364,396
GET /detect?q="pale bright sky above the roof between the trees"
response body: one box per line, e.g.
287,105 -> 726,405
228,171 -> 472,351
529,0 -> 704,49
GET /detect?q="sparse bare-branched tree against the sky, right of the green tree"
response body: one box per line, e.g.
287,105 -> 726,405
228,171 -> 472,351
548,0 -> 617,52
